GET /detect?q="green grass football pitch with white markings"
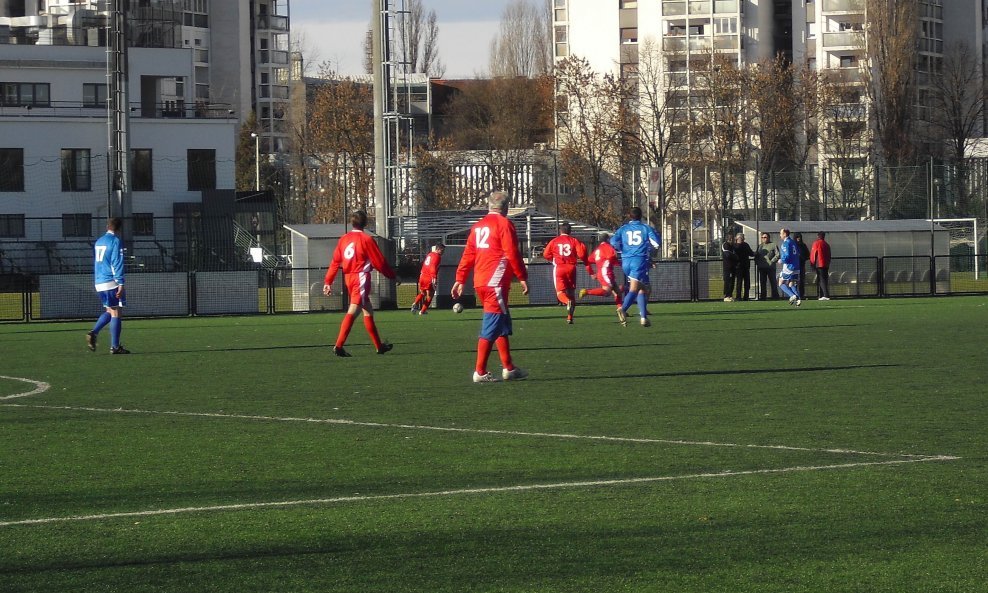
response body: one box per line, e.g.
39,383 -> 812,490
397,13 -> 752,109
0,297 -> 988,593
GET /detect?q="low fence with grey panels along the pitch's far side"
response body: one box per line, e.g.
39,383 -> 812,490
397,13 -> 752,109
0,255 -> 988,322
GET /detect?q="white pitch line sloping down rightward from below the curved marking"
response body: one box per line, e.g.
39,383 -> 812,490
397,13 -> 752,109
0,404 -> 960,461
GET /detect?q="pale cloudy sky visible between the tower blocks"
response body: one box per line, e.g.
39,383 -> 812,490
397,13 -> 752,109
290,0 -> 511,78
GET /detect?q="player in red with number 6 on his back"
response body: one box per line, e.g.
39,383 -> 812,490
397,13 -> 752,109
322,210 -> 395,356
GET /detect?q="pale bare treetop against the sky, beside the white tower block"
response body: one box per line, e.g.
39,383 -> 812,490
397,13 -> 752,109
489,0 -> 552,78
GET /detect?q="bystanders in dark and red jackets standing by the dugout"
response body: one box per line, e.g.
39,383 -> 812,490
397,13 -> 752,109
721,231 -> 830,302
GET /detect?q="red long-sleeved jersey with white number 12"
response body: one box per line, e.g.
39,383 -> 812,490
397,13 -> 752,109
456,212 -> 528,288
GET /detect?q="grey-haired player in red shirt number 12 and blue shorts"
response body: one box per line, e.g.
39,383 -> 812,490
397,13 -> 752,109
450,191 -> 528,383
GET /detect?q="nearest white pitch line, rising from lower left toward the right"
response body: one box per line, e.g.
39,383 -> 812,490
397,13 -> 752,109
0,456 -> 957,527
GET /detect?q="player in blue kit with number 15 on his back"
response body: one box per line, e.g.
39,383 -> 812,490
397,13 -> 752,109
611,207 -> 662,327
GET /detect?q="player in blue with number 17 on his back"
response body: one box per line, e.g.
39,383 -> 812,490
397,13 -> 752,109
86,218 -> 130,354
